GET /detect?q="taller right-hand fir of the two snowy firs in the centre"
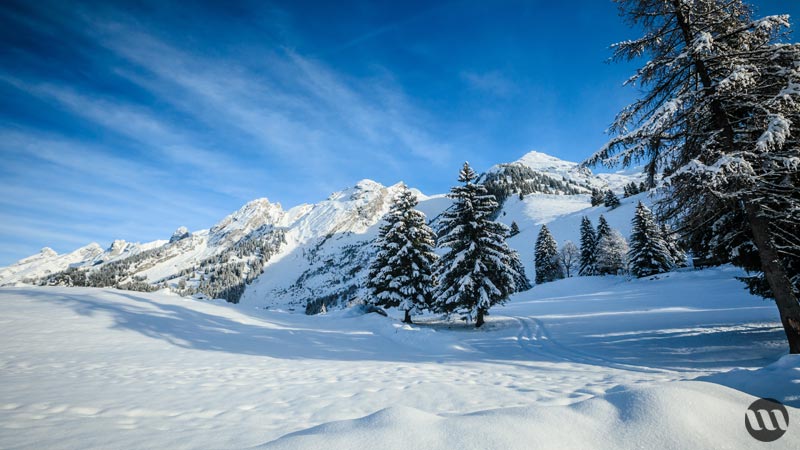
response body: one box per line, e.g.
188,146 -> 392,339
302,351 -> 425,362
435,163 -> 524,327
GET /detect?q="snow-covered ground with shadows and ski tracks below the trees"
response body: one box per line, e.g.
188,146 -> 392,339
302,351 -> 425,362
0,268 -> 800,449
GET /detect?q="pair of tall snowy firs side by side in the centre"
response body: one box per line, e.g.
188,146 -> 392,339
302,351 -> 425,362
367,163 -> 530,327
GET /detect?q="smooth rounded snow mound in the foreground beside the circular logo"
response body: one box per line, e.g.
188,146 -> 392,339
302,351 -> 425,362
258,381 -> 800,450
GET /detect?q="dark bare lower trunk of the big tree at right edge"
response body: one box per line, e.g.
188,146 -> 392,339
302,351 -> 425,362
745,201 -> 800,354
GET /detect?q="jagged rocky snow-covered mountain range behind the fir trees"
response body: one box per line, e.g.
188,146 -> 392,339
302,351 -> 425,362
0,152 -> 638,312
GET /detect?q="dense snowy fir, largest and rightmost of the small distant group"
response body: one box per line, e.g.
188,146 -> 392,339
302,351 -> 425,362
628,202 -> 673,278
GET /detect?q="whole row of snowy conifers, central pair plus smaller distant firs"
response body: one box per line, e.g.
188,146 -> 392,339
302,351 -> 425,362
366,163 -> 685,318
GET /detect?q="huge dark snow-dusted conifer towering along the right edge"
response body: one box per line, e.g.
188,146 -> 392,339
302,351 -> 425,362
587,0 -> 800,353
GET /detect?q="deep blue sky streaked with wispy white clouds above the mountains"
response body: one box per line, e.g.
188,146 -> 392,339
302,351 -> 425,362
0,0 -> 800,265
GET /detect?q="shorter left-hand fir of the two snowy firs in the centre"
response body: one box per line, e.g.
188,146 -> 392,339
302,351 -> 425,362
367,185 -> 437,323
